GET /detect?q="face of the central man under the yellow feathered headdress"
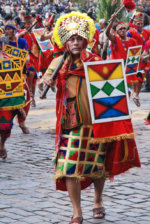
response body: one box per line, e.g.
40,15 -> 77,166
67,35 -> 84,56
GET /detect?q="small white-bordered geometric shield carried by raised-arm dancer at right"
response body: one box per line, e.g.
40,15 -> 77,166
125,46 -> 142,75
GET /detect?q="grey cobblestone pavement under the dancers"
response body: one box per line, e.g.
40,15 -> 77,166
0,91 -> 150,224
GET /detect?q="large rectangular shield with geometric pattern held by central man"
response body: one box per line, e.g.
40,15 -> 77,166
86,61 -> 129,123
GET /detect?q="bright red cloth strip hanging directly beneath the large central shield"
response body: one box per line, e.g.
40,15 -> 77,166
93,119 -> 133,138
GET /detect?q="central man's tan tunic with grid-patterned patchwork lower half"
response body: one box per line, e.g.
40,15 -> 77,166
55,75 -> 105,189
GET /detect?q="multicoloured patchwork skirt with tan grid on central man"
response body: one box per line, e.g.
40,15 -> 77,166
56,125 -> 105,178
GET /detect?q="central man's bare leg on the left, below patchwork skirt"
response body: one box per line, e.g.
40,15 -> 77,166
66,177 -> 82,217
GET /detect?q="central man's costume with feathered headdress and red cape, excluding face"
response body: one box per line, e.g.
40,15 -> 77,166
45,12 -> 140,191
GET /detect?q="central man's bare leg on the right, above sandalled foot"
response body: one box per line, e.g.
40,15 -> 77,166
93,177 -> 105,217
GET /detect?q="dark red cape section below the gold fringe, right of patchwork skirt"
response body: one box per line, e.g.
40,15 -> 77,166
105,139 -> 141,176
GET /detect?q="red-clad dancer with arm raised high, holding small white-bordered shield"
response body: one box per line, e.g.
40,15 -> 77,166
106,13 -> 140,106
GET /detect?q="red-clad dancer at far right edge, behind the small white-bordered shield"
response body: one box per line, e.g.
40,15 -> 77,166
127,12 -> 150,106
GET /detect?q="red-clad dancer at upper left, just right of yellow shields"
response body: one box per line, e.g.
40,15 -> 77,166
17,15 -> 39,107
